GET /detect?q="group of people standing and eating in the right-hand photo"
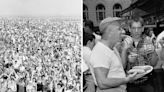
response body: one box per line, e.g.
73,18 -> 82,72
82,16 -> 164,92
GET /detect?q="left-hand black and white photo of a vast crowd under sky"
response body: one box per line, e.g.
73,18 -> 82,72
0,0 -> 82,92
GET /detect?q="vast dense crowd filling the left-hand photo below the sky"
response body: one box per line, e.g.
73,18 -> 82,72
0,17 -> 81,92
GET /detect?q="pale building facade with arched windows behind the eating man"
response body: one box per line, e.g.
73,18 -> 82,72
83,0 -> 131,26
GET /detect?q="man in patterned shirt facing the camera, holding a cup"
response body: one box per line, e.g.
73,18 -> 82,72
122,17 -> 158,92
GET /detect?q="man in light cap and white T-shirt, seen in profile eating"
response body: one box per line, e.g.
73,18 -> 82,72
90,17 -> 136,92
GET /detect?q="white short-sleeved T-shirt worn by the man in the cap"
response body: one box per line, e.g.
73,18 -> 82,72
90,42 -> 126,89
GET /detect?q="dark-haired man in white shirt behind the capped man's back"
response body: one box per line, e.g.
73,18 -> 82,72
82,32 -> 96,92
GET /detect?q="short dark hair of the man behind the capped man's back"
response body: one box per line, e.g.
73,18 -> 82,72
83,31 -> 95,46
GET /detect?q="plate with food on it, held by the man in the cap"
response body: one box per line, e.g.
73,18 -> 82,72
127,65 -> 153,79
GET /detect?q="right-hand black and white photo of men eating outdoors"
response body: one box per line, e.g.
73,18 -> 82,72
81,0 -> 164,92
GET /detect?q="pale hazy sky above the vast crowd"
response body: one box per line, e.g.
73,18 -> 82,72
0,0 -> 82,16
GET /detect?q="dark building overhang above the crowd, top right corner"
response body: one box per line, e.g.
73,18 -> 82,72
120,0 -> 164,35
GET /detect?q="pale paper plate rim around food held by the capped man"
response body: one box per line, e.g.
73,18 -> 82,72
129,65 -> 153,79
